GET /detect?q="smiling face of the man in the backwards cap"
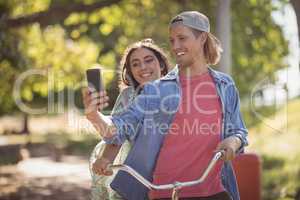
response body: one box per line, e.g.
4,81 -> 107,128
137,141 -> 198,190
170,24 -> 203,67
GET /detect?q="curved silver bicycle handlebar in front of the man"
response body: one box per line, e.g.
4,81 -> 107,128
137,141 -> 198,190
108,150 -> 224,200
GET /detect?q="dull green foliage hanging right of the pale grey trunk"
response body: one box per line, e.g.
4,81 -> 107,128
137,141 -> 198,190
232,0 -> 288,97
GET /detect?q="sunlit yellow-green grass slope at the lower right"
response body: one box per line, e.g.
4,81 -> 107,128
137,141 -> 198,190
248,99 -> 300,200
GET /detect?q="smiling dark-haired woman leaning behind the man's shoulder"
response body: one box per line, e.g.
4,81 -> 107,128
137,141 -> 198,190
90,39 -> 169,200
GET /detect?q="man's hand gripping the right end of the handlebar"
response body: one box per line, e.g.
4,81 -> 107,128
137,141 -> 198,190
216,136 -> 242,161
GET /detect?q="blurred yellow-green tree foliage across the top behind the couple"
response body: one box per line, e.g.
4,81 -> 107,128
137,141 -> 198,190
0,0 -> 287,114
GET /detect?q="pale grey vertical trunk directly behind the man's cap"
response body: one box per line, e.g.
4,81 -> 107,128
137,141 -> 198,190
216,0 -> 231,74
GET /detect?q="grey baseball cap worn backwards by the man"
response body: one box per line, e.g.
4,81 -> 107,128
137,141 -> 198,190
170,11 -> 210,33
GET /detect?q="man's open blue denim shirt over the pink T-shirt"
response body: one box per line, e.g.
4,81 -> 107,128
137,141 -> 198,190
104,67 -> 248,200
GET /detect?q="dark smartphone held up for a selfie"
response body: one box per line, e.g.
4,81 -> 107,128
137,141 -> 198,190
86,68 -> 104,92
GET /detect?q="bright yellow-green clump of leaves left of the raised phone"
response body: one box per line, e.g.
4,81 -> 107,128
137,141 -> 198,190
21,25 -> 98,88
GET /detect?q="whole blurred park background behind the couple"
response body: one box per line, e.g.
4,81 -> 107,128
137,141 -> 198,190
0,0 -> 300,200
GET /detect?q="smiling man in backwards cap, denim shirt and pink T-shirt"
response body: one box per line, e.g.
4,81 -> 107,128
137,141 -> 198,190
85,11 -> 248,200
